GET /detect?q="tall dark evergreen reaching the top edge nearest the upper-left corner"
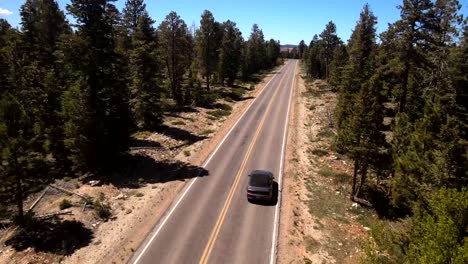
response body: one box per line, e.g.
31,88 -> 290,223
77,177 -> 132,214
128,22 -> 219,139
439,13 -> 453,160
20,0 -> 71,166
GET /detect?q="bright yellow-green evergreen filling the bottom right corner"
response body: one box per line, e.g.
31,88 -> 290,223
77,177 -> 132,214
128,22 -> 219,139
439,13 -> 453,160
407,188 -> 468,264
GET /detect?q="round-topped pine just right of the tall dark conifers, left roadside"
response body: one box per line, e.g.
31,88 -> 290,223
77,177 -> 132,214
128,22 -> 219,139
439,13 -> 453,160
159,12 -> 193,105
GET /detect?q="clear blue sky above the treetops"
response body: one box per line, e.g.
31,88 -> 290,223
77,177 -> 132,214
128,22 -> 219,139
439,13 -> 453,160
0,0 -> 468,44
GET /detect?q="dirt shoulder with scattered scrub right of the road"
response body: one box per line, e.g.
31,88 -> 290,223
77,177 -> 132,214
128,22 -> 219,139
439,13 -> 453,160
278,62 -> 367,263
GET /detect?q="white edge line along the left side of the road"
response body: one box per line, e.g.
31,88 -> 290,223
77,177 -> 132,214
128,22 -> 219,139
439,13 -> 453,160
133,61 -> 289,264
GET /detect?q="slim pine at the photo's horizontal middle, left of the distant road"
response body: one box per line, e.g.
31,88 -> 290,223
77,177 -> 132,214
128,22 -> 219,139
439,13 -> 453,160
218,20 -> 243,86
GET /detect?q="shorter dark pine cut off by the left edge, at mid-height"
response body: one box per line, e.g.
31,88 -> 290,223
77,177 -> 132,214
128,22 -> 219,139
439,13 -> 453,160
0,88 -> 49,226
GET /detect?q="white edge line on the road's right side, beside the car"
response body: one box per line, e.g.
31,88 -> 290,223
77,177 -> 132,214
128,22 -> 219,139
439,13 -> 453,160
270,61 -> 297,264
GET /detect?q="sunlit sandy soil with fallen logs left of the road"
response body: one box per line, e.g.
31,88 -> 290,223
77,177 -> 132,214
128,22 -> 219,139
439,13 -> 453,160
0,63 -> 284,263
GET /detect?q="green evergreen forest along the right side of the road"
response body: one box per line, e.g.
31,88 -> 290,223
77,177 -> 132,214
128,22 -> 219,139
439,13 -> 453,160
302,0 -> 468,263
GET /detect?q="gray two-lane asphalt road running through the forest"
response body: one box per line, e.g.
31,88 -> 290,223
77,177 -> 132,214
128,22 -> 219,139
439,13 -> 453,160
130,60 -> 296,263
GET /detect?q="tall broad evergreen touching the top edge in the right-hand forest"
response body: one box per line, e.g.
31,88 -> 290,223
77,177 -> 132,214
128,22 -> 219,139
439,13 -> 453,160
383,0 -> 457,118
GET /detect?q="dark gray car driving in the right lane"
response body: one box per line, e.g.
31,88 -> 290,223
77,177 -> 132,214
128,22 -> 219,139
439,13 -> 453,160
247,170 -> 273,201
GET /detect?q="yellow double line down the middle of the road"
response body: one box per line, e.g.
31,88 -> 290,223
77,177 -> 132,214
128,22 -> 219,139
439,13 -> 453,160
199,63 -> 286,264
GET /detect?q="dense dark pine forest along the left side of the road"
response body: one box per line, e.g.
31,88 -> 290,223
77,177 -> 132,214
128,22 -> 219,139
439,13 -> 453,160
0,0 -> 280,226
